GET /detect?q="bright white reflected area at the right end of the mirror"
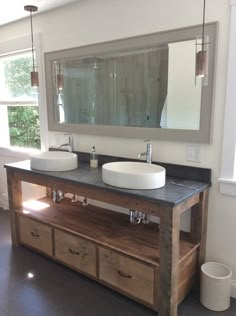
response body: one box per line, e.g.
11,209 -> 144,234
166,40 -> 202,130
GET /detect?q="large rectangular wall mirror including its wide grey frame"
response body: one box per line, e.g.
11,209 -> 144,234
45,23 -> 216,143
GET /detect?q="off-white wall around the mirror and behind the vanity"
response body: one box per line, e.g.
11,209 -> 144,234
0,0 -> 236,288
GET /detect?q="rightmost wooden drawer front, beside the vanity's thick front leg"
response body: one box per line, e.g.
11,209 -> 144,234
99,248 -> 154,304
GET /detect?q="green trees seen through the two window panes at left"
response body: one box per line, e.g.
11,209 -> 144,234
4,56 -> 40,148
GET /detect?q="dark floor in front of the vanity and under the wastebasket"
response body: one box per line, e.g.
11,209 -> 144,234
0,210 -> 236,316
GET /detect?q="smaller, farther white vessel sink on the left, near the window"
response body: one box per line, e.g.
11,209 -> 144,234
30,151 -> 78,171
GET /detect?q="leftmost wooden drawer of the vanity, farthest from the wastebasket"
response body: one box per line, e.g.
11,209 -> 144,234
19,216 -> 52,256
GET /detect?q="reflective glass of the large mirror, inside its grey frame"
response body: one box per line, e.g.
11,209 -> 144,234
53,41 -> 201,130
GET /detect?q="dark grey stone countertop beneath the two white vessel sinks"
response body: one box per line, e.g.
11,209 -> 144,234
5,160 -> 210,206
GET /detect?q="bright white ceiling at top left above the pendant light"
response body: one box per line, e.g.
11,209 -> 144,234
0,0 -> 78,26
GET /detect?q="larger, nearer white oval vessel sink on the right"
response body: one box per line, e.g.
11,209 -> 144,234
102,161 -> 166,189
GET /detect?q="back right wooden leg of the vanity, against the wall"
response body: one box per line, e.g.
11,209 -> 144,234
190,189 -> 209,272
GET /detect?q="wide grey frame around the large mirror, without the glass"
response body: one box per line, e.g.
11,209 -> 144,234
45,22 -> 218,143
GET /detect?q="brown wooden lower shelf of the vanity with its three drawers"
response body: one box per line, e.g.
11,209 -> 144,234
16,198 -> 199,310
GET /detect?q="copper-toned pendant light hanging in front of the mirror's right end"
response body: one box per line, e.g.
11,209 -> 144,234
196,0 -> 209,78
